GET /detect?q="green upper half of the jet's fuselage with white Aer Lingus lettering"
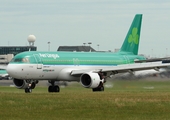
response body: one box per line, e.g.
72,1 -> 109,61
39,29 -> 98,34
10,51 -> 145,65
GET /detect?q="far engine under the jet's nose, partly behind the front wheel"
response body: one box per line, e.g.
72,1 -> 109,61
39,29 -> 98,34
13,78 -> 29,89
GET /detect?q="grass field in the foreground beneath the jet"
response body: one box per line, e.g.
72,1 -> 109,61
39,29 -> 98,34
0,80 -> 170,120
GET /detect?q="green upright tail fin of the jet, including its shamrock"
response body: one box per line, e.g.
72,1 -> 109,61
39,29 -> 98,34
120,14 -> 142,55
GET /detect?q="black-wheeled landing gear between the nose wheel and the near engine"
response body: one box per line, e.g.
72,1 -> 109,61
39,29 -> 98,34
48,80 -> 60,93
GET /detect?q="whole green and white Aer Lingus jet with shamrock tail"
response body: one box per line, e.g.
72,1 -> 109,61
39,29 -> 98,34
4,14 -> 170,93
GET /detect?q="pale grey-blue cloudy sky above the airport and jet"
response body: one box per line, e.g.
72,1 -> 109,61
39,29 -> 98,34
0,0 -> 170,57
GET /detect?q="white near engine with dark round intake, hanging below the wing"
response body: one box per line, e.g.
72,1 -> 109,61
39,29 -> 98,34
80,72 -> 104,88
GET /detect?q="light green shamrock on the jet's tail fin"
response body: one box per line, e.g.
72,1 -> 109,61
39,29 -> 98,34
128,27 -> 139,46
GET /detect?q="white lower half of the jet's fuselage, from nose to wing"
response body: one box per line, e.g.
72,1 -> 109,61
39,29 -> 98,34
7,64 -> 108,81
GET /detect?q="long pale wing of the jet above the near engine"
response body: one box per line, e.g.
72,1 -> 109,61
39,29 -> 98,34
71,62 -> 170,76
